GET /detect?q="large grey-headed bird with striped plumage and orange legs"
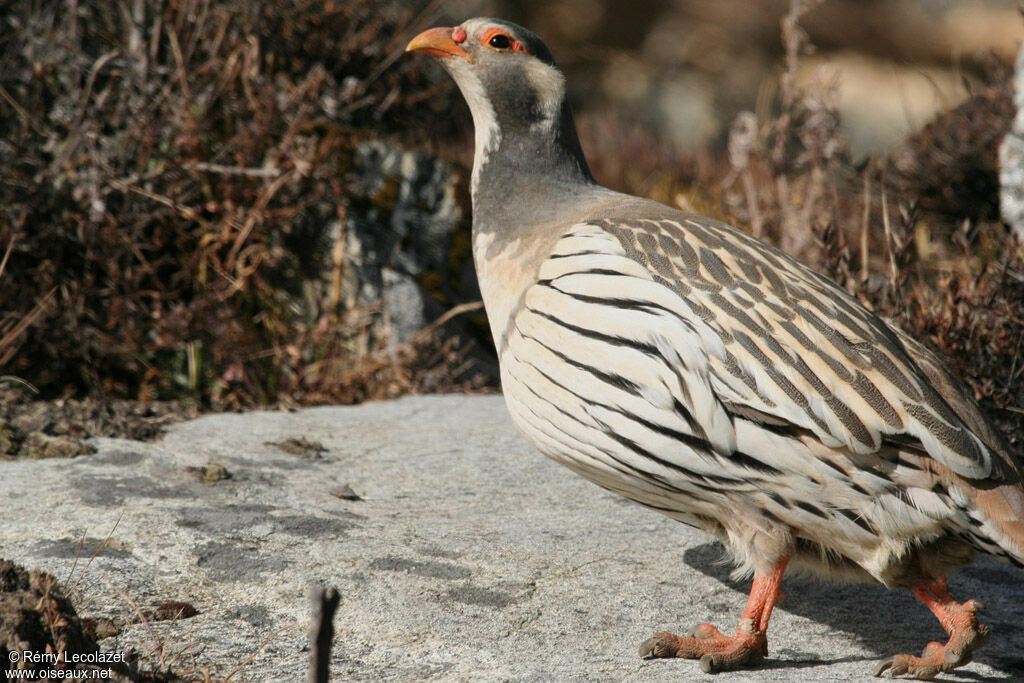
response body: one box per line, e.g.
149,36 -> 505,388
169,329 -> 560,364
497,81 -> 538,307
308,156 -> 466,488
407,17 -> 1024,679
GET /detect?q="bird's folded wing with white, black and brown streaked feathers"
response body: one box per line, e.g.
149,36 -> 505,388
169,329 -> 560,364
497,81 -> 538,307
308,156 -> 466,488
516,214 -> 992,479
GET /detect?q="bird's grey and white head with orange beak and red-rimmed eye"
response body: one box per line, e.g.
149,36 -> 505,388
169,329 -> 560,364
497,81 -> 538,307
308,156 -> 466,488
406,17 -> 565,138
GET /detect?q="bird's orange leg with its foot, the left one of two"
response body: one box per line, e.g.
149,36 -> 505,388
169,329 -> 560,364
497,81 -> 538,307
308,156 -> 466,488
640,555 -> 790,674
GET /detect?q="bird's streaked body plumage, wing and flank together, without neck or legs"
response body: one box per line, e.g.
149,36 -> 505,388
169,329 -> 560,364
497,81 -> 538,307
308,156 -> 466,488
501,220 -> 1024,583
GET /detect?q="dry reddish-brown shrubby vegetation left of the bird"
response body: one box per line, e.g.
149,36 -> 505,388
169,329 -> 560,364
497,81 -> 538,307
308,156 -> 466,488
0,0 -> 479,417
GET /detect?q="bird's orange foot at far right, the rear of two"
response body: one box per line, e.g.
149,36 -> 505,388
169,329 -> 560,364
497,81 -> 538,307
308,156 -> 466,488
874,600 -> 989,681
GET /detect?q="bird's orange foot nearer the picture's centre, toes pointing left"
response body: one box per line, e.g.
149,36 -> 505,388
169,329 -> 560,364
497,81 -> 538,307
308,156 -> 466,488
640,618 -> 768,674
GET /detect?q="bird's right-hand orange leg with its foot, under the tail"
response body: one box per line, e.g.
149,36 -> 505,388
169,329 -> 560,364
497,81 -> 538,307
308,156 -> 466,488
874,571 -> 988,680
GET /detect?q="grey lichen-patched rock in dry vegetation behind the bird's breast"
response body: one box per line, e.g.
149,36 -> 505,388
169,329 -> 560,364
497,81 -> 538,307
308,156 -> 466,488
282,139 -> 480,352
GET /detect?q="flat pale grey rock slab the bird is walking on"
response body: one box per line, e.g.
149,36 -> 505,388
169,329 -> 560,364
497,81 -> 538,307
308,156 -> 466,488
0,396 -> 1024,681
